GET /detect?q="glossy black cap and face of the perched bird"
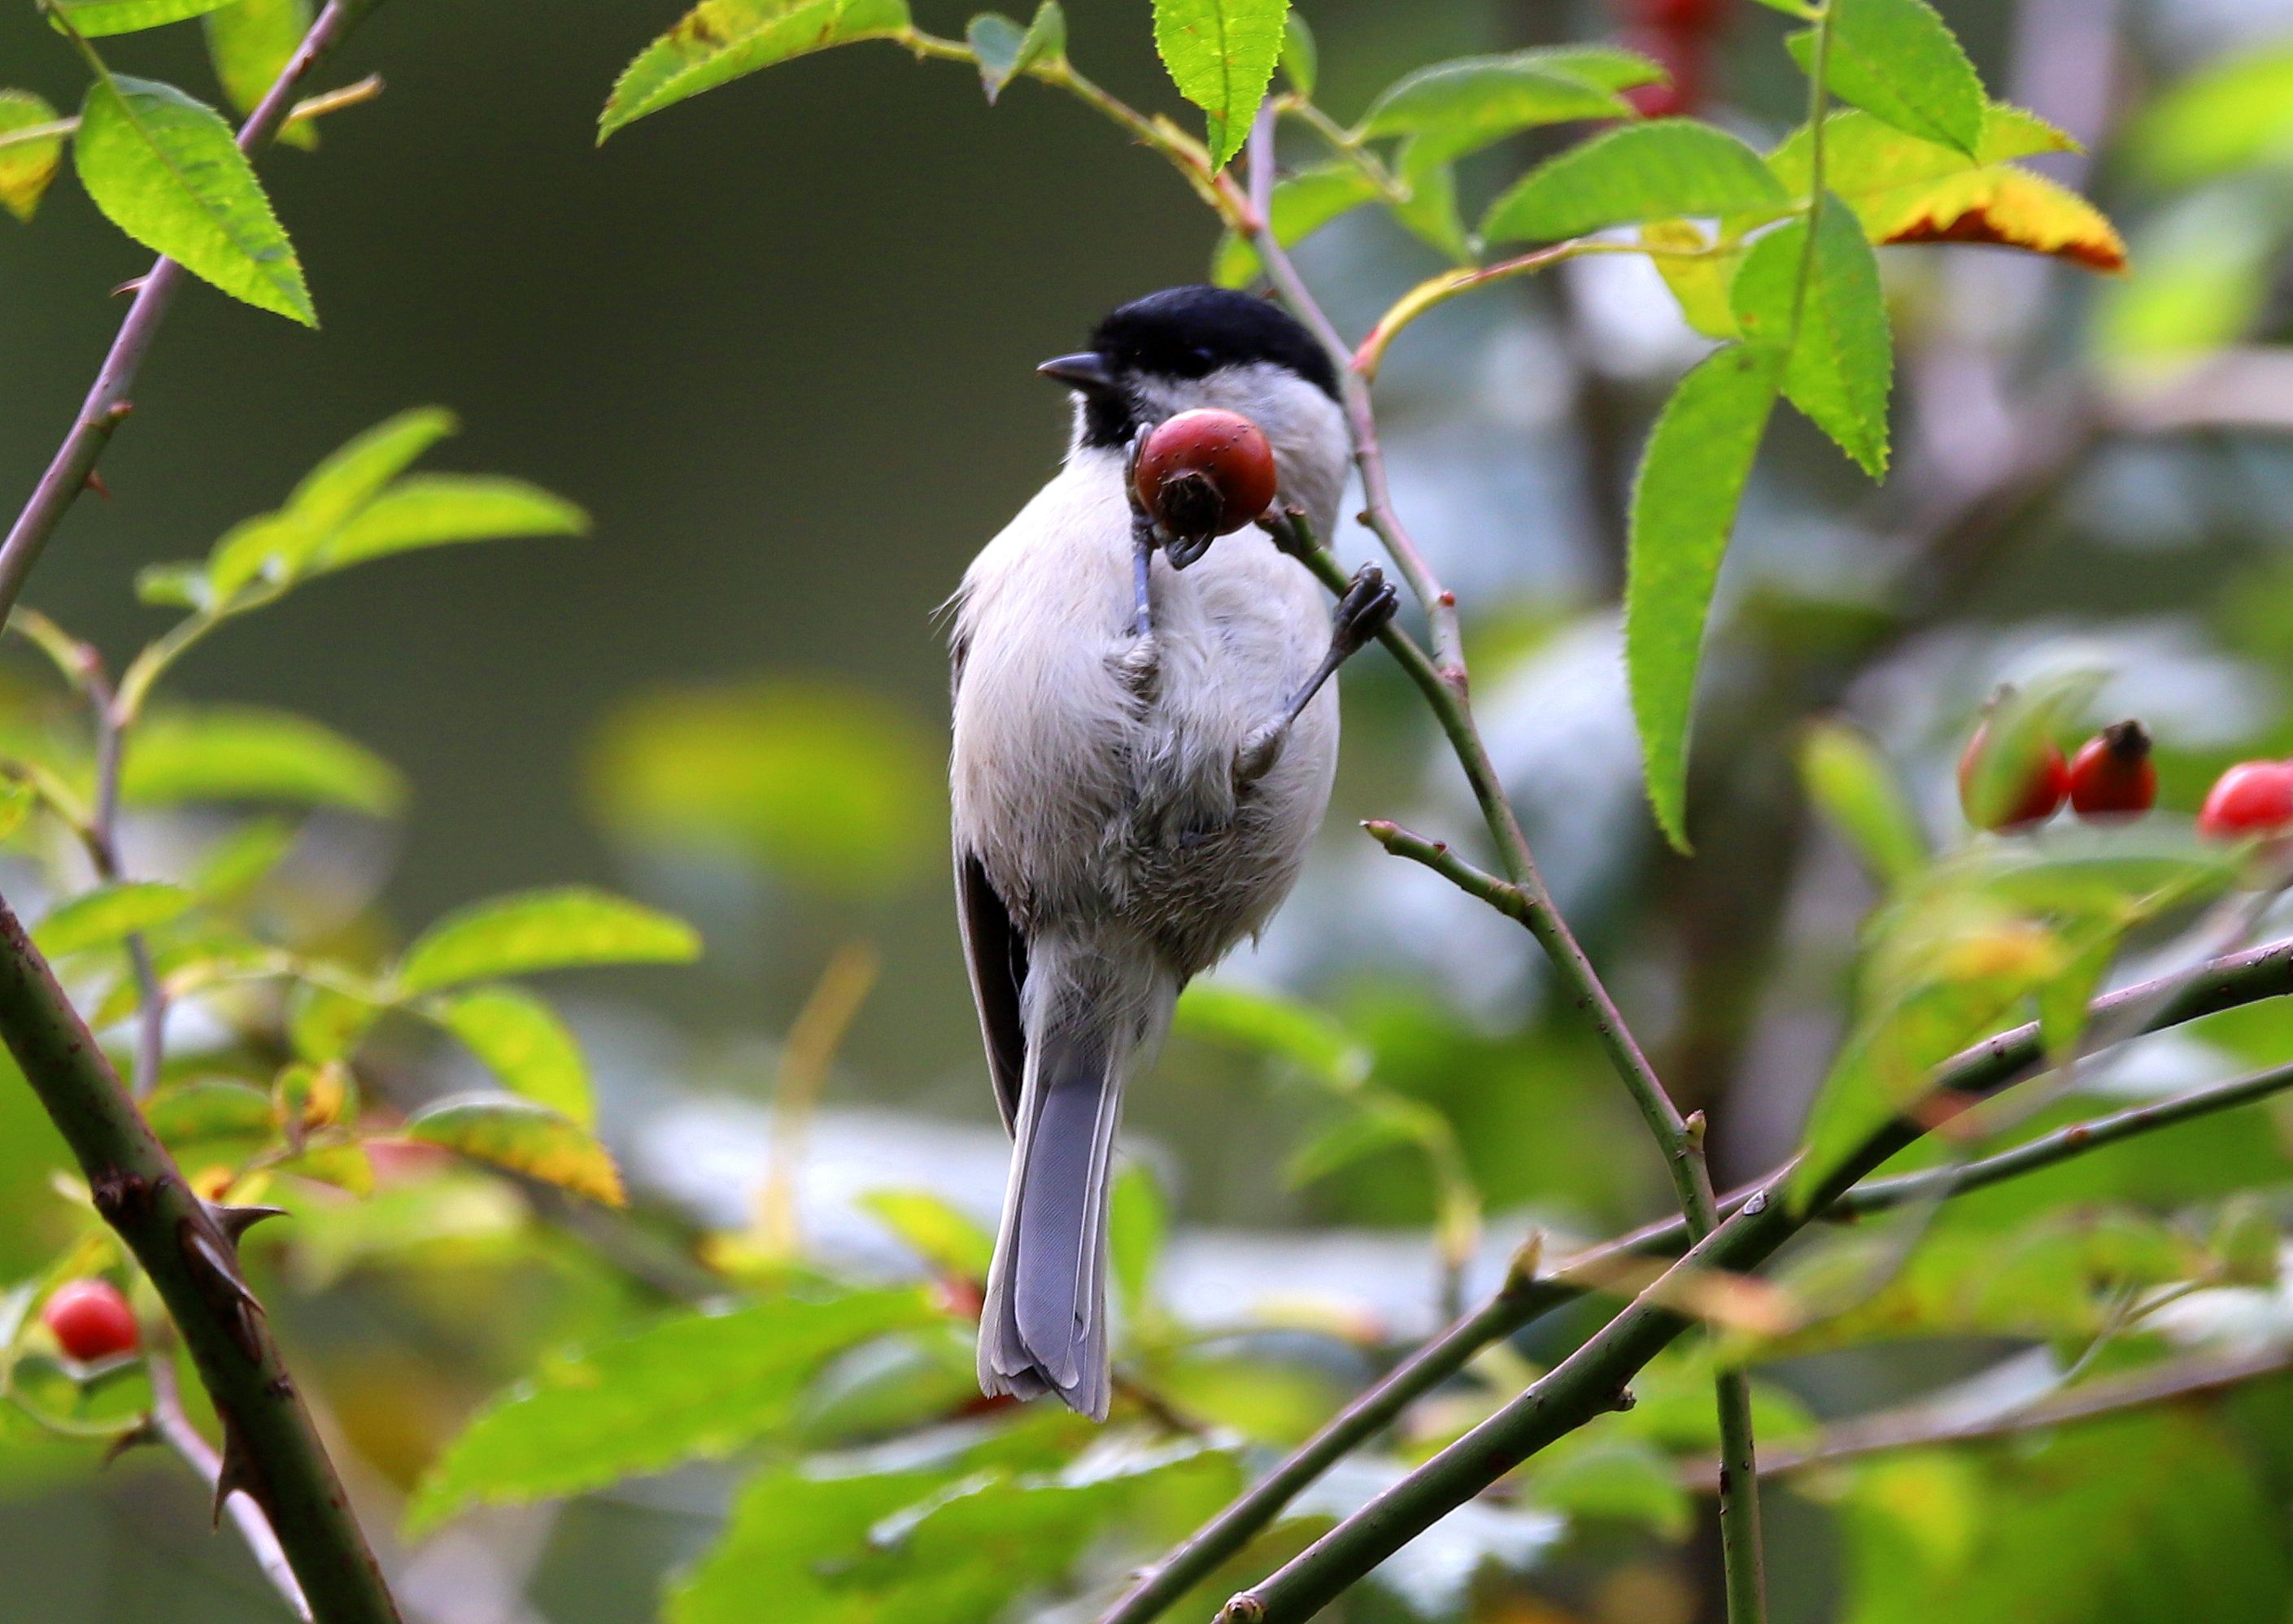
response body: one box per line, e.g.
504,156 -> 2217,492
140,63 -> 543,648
1036,287 -> 1336,445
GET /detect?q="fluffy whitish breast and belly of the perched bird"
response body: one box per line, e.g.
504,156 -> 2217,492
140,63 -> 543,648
952,447 -> 1336,973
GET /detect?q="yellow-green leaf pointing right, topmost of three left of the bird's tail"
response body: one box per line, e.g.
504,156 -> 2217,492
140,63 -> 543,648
397,886 -> 702,993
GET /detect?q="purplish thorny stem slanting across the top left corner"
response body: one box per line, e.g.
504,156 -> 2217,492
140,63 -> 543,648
0,0 -> 381,621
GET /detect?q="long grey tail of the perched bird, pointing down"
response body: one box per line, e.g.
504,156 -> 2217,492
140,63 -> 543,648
979,940 -> 1176,1420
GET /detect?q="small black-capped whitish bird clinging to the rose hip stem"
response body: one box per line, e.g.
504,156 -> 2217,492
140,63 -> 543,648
949,287 -> 1394,1420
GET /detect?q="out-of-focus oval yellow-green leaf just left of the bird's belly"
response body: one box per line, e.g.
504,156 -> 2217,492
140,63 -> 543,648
587,679 -> 943,897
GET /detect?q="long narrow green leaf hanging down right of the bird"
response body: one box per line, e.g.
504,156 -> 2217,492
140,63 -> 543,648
1624,344 -> 1777,851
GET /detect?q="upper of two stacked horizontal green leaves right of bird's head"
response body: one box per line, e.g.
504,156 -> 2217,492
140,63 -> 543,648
1353,50 -> 1663,163
